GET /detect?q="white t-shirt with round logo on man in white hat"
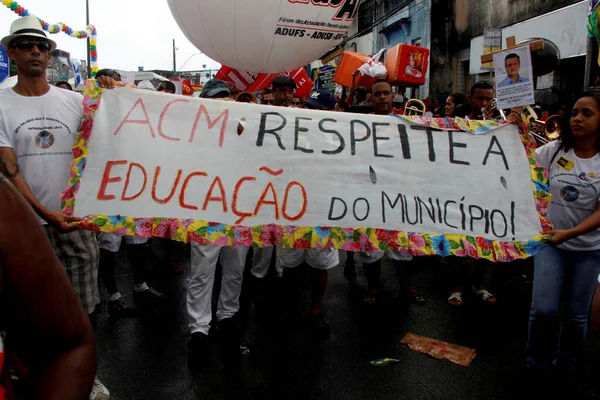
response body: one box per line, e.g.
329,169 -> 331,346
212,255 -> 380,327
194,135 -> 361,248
0,86 -> 83,222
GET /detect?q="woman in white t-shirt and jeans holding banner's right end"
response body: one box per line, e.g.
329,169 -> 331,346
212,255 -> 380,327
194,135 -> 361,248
527,95 -> 600,373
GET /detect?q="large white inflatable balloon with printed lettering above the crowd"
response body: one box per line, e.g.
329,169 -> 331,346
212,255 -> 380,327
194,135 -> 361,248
167,0 -> 359,73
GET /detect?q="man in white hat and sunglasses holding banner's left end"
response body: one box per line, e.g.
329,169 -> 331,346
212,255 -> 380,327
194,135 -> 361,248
0,17 -> 114,400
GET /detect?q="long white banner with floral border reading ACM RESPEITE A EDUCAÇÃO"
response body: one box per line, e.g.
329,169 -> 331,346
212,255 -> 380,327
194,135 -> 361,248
62,81 -> 550,261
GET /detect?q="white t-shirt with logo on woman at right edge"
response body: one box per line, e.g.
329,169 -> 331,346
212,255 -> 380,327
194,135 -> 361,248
535,141 -> 600,251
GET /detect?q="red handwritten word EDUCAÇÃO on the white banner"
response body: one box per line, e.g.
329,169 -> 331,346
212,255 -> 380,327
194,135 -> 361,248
97,160 -> 308,224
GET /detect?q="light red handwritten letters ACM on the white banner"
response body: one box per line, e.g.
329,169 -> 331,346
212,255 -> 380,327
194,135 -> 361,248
114,98 -> 229,147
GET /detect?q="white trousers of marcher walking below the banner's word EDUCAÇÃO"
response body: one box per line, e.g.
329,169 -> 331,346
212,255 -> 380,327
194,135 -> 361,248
187,243 -> 248,335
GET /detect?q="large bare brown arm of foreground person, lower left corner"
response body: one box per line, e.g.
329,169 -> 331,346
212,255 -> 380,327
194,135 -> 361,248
0,177 -> 96,400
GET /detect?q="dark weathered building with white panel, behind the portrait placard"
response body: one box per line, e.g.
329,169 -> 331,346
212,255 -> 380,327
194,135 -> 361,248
431,0 -> 589,104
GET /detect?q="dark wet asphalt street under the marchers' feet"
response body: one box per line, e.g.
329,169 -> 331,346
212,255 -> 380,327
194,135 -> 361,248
96,243 -> 600,400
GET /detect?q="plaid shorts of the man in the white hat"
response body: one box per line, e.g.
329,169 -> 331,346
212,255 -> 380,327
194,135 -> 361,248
44,225 -> 100,314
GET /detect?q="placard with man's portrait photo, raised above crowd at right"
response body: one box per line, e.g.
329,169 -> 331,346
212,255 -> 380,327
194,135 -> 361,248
494,46 -> 535,109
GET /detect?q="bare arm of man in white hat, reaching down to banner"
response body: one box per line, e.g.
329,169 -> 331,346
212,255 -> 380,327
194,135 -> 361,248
0,147 -> 79,232
